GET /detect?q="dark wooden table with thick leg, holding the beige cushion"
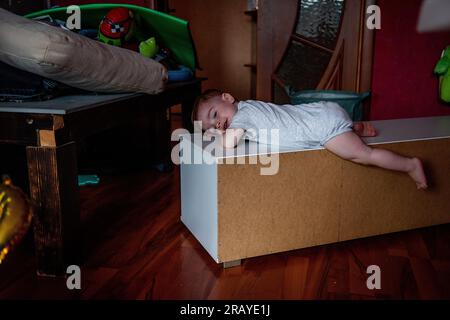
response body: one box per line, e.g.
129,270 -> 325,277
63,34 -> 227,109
0,79 -> 202,276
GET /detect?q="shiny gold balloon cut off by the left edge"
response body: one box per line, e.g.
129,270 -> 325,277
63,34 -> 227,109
0,176 -> 33,264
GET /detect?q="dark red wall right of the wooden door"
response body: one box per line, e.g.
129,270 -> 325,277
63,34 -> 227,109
370,0 -> 450,120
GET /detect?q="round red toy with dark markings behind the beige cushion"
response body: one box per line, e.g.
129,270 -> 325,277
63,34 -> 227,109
98,7 -> 134,47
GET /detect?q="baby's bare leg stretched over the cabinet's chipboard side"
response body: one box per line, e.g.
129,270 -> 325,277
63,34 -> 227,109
325,132 -> 427,189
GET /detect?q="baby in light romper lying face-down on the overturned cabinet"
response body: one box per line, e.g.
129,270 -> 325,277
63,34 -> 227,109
192,89 -> 427,189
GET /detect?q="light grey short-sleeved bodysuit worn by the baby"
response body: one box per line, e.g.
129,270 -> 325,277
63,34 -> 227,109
229,100 -> 353,149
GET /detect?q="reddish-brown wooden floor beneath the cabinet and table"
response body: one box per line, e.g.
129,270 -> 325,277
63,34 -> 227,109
0,115 -> 450,299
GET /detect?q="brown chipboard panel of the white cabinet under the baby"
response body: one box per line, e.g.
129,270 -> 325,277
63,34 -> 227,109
217,138 -> 450,262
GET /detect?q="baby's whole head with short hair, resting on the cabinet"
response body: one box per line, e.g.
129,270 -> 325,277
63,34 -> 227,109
192,89 -> 237,130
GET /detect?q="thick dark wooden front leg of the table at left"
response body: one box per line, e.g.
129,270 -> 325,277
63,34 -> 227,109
27,142 -> 81,276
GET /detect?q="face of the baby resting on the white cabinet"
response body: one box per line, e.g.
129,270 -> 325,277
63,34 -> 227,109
198,93 -> 237,130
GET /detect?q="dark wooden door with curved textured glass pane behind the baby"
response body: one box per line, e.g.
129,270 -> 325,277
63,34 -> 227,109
257,0 -> 375,109
